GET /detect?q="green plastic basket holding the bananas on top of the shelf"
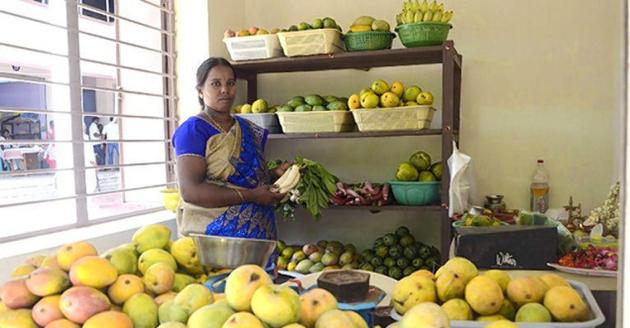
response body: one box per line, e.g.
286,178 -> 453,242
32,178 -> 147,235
396,22 -> 453,48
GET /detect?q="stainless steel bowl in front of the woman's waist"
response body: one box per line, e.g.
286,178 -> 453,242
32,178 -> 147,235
190,233 -> 276,269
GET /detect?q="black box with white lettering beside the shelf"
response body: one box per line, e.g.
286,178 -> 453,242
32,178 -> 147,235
455,225 -> 558,270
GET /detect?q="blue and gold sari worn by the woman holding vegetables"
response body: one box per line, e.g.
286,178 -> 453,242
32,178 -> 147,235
173,116 -> 276,240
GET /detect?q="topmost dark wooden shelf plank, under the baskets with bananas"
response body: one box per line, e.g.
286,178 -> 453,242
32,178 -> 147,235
232,41 -> 452,74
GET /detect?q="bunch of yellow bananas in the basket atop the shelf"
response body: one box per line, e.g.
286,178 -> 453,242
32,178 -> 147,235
396,0 -> 453,25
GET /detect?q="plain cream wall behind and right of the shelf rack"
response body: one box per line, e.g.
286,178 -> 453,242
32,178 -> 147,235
204,0 -> 624,250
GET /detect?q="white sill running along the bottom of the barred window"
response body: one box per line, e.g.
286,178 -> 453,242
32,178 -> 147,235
0,210 -> 175,259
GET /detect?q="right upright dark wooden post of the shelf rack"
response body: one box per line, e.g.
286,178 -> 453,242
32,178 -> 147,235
440,41 -> 458,263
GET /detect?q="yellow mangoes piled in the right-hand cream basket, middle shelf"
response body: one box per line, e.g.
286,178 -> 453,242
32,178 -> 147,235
348,79 -> 433,110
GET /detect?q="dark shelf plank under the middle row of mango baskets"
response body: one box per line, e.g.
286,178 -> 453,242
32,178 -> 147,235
269,129 -> 442,139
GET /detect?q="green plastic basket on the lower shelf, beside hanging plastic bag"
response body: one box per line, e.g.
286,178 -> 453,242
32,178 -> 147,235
389,180 -> 441,205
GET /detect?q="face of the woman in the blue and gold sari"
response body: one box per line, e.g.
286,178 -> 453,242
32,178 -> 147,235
200,65 -> 236,113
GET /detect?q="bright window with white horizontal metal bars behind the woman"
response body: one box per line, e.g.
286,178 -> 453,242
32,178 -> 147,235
0,0 -> 177,242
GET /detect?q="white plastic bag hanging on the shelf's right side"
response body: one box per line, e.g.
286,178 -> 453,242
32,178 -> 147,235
448,141 -> 474,217
